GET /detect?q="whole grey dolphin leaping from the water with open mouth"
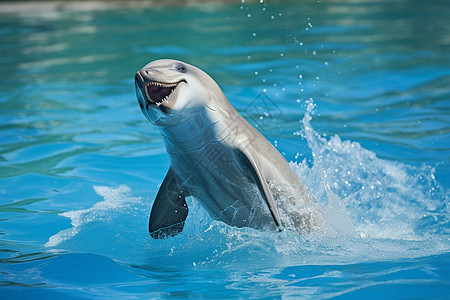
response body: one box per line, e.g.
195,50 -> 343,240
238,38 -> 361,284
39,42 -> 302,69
135,59 -> 320,238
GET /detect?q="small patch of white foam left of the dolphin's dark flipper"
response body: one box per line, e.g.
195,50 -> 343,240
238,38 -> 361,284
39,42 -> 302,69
45,185 -> 137,247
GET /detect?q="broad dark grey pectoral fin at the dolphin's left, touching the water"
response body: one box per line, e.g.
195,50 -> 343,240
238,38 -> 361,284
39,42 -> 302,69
148,168 -> 188,239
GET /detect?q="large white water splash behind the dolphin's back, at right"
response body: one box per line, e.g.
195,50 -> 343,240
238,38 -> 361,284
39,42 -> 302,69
293,99 -> 449,240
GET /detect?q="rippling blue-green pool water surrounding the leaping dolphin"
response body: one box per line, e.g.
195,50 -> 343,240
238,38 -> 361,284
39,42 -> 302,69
0,0 -> 450,299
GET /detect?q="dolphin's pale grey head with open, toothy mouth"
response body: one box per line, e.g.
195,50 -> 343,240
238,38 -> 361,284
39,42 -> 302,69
135,59 -> 223,126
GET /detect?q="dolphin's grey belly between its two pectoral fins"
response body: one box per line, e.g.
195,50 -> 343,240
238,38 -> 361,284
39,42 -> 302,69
170,142 -> 275,229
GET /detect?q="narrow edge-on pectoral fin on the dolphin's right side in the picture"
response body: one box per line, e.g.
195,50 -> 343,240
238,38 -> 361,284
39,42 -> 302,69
237,152 -> 282,231
